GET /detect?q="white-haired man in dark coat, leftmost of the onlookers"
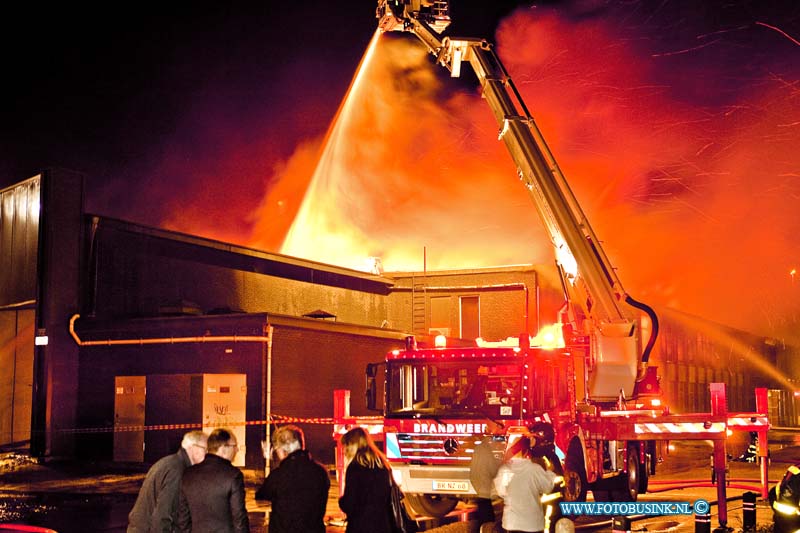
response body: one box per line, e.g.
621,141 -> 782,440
128,431 -> 208,533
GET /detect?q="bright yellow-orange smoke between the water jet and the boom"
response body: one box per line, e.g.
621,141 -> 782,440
264,36 -> 548,270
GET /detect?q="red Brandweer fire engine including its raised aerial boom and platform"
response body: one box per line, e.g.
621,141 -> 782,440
346,0 -> 768,522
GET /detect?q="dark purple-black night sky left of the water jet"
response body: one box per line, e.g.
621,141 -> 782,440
0,0 -> 518,229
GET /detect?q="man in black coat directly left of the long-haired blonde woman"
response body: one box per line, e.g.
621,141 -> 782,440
256,425 -> 331,533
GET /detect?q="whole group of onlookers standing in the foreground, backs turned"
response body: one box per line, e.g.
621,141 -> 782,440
128,425 -> 557,533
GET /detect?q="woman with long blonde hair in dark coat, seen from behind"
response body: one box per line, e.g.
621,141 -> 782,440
339,427 -> 392,533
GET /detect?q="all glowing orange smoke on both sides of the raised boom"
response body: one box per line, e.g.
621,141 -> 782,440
247,5 -> 800,337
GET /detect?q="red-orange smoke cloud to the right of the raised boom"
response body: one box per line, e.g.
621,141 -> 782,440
488,6 -> 800,337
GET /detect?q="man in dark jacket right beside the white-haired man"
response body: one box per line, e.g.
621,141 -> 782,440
178,428 -> 250,533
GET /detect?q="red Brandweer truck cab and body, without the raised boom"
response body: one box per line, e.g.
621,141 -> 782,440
367,340 -> 664,516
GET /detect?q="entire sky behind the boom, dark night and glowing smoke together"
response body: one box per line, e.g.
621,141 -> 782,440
0,0 -> 800,338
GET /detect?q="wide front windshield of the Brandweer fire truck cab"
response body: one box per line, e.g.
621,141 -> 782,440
387,361 -> 522,419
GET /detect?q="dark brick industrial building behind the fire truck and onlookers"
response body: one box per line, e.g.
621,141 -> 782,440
0,170 -> 796,467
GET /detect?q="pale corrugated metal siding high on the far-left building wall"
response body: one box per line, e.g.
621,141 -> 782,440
0,176 -> 40,307
